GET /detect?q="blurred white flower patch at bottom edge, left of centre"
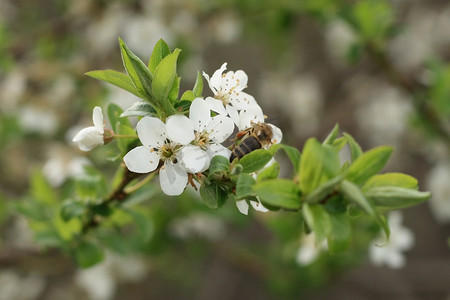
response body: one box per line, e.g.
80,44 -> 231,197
75,252 -> 148,300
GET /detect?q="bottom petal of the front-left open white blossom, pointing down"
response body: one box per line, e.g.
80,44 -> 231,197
159,161 -> 188,196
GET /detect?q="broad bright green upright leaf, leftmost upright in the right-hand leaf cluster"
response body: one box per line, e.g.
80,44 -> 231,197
299,138 -> 340,194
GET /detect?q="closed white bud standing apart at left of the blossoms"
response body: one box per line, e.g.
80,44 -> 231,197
73,106 -> 105,151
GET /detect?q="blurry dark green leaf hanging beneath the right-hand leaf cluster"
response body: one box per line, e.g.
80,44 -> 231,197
327,214 -> 352,253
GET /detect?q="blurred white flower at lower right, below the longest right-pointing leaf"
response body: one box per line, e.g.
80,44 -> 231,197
369,211 -> 414,269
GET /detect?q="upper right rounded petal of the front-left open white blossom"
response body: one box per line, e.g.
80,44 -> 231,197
166,115 -> 195,145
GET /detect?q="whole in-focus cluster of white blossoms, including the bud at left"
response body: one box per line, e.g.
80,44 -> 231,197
73,63 -> 282,196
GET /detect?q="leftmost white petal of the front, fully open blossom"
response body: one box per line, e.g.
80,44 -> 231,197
123,146 -> 159,173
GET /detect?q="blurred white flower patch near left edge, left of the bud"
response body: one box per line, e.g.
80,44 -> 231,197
19,105 -> 58,135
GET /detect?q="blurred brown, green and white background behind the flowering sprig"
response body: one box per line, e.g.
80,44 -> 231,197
0,0 -> 450,300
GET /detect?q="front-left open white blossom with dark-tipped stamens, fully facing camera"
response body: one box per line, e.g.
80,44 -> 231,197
123,115 -> 195,196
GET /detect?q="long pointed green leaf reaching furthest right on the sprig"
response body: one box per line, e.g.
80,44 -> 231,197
365,186 -> 431,209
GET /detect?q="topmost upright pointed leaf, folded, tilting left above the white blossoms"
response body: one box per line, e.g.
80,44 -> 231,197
119,38 -> 152,100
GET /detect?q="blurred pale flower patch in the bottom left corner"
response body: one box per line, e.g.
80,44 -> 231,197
0,269 -> 45,300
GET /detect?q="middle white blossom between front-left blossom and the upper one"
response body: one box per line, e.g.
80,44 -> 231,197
178,98 -> 234,173
